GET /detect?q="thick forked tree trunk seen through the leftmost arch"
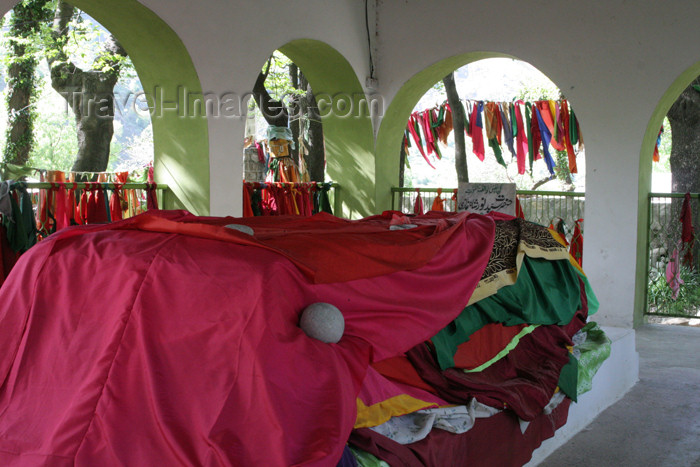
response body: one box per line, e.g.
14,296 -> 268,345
48,2 -> 126,172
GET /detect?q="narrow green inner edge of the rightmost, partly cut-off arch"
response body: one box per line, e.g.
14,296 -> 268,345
633,62 -> 700,327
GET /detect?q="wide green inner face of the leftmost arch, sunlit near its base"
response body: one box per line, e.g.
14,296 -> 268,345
70,0 -> 210,215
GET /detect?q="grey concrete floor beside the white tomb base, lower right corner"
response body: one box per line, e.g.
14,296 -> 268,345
540,325 -> 700,467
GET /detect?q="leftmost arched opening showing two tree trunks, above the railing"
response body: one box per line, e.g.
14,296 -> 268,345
0,2 -> 153,176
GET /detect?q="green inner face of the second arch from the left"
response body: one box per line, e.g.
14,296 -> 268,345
279,39 -> 376,218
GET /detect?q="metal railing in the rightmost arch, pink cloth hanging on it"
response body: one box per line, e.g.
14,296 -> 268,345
644,193 -> 700,318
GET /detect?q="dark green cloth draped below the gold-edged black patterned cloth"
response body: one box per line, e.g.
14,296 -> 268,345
432,256 -> 581,370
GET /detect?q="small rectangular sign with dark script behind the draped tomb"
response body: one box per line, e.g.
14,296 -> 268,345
457,183 -> 515,216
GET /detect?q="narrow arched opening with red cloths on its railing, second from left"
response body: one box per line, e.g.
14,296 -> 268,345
242,50 -> 333,217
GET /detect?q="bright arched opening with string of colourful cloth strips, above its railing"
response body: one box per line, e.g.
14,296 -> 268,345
404,58 -> 585,191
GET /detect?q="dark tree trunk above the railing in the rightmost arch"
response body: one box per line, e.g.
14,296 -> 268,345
667,79 -> 700,193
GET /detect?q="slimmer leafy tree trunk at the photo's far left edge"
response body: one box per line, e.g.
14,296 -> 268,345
3,0 -> 50,174
